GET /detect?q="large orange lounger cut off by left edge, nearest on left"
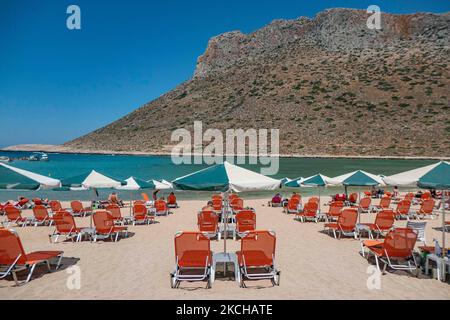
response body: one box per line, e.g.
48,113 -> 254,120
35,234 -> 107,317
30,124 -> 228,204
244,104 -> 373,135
0,229 -> 63,285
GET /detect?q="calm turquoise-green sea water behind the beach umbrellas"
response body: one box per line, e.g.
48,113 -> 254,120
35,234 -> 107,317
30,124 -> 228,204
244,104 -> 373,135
0,152 -> 436,201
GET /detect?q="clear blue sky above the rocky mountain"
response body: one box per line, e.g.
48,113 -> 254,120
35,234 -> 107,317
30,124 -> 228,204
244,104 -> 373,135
0,0 -> 450,147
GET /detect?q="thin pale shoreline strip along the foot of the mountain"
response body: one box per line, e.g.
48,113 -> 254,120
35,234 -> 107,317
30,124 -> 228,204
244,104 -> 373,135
0,144 -> 450,161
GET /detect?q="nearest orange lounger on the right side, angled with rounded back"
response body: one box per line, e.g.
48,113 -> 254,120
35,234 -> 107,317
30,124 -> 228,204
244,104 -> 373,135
361,228 -> 417,273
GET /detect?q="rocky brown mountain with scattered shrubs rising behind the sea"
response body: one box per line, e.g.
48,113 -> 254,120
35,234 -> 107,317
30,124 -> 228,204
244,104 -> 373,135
63,9 -> 450,157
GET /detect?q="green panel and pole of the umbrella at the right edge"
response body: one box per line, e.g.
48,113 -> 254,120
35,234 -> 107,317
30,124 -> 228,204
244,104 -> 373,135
417,161 -> 450,262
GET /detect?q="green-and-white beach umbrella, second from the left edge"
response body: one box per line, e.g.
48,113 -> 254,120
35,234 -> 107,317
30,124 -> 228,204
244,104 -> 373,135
61,170 -> 126,190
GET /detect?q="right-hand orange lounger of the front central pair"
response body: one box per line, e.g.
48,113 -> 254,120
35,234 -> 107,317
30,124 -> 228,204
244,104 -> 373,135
236,231 -> 280,288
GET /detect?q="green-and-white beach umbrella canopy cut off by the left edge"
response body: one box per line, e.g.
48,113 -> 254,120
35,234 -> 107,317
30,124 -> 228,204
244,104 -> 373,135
0,163 -> 61,190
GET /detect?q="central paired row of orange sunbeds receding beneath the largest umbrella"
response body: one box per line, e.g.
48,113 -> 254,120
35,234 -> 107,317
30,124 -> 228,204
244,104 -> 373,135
170,195 -> 280,288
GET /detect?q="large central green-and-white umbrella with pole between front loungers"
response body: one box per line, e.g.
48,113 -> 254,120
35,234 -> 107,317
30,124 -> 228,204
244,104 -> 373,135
172,161 -> 281,253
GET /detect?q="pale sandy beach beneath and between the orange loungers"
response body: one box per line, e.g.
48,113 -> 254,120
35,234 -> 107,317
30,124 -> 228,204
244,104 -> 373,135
0,196 -> 450,300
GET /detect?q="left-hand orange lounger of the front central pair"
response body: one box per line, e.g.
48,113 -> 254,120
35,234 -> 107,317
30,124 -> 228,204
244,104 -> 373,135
170,232 -> 212,289
